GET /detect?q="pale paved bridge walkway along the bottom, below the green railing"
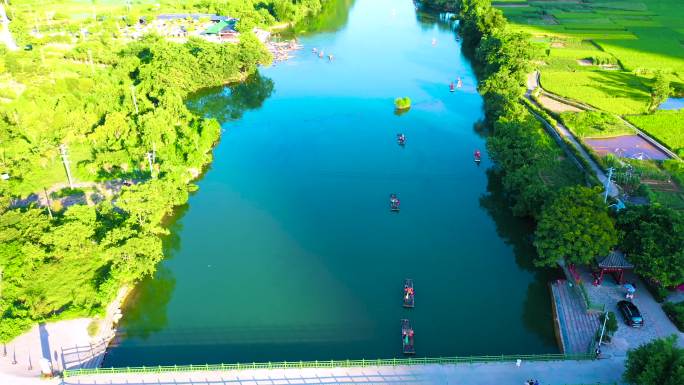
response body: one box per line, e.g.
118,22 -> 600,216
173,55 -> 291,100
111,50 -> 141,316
54,358 -> 624,385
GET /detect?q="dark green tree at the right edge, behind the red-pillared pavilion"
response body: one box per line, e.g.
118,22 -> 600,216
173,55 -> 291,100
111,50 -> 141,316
617,206 -> 684,286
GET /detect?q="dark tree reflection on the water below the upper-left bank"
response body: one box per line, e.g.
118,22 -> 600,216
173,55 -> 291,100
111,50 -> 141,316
187,71 -> 273,123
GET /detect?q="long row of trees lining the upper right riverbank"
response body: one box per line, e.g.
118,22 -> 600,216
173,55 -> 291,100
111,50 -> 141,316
459,0 -> 582,217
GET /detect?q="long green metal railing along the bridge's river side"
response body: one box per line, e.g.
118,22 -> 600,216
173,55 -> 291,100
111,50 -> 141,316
62,353 -> 595,378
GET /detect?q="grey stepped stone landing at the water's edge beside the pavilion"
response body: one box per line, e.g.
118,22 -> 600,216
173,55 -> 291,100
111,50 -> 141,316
550,280 -> 599,354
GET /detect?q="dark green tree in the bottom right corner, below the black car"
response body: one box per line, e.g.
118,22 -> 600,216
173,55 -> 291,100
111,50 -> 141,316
624,336 -> 684,385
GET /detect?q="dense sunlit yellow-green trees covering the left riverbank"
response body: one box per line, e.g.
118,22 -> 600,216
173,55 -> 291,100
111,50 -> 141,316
0,0 -> 321,341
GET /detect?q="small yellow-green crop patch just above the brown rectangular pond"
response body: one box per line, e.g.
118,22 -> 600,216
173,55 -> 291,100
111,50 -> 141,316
561,111 -> 634,138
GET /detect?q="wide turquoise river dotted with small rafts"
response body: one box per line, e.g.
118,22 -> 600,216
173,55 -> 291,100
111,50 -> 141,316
104,0 -> 558,366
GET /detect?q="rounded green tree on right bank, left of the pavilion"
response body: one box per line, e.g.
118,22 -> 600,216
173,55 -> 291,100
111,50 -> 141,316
534,186 -> 617,266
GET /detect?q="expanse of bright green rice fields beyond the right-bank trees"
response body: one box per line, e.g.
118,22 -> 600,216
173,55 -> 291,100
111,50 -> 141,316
493,0 -> 684,206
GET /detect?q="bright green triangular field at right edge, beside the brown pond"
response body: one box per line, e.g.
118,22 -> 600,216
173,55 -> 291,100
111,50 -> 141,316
627,110 -> 684,156
